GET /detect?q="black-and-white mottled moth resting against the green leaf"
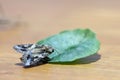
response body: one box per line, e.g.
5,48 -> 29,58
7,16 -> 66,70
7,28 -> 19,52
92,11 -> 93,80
13,44 -> 54,68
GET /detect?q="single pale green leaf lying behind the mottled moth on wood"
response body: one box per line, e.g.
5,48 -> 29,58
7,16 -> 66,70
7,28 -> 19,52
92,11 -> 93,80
37,29 -> 100,62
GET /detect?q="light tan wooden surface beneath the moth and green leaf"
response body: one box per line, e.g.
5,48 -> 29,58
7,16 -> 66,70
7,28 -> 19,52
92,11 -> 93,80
0,0 -> 120,80
